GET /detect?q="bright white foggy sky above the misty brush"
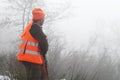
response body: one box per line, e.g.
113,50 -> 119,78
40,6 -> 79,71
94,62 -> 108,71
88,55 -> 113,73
0,0 -> 120,46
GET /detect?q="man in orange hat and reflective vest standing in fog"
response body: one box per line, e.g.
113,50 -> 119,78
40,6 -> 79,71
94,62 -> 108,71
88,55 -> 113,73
18,8 -> 48,80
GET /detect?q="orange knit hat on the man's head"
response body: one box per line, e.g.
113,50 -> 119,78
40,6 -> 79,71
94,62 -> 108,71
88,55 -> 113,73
32,8 -> 45,20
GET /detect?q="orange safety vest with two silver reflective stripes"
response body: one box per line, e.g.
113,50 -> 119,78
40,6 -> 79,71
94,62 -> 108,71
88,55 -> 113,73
18,22 -> 43,64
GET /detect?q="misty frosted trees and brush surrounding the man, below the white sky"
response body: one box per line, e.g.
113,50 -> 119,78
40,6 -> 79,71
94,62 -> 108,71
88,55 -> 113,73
0,0 -> 120,80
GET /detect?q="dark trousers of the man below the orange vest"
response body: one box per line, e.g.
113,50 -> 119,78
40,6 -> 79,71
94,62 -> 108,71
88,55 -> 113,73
22,62 -> 43,80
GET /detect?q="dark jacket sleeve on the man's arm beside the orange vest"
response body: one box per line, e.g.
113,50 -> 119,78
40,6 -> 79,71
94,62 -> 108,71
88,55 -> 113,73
30,24 -> 48,55
